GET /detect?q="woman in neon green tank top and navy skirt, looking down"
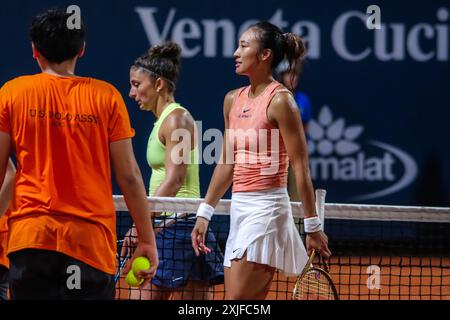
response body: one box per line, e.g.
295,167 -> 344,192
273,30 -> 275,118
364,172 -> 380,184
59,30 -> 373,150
124,42 -> 223,300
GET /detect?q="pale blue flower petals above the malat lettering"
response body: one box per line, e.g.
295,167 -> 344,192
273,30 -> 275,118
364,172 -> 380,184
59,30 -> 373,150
308,105 -> 363,156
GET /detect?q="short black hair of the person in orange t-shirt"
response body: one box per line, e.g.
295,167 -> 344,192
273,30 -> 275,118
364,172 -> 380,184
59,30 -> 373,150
30,8 -> 86,63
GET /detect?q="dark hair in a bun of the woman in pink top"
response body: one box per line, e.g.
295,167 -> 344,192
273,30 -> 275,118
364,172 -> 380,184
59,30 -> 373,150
250,21 -> 306,76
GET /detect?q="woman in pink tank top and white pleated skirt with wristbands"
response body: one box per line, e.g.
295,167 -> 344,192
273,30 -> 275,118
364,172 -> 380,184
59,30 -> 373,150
192,22 -> 331,300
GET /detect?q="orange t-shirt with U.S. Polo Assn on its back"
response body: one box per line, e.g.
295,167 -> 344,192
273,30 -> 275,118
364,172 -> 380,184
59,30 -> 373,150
0,73 -> 134,274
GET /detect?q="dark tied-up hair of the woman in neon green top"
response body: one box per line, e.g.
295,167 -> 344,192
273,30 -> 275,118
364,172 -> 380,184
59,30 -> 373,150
133,41 -> 181,92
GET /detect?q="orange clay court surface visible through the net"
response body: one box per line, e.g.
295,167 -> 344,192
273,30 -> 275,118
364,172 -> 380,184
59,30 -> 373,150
117,256 -> 450,300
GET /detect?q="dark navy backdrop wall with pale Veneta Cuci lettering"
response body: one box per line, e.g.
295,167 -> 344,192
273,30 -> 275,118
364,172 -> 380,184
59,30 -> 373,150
0,0 -> 450,206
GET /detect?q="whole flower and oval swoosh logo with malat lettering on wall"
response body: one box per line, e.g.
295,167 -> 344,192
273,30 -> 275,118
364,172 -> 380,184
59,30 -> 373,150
308,105 -> 417,201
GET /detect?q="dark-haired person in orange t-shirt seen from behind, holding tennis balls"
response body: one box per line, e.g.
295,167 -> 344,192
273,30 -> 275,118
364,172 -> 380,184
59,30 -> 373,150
0,10 -> 158,299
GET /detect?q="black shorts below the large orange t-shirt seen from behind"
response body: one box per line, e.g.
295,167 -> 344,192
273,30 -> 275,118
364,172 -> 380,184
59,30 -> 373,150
8,249 -> 115,300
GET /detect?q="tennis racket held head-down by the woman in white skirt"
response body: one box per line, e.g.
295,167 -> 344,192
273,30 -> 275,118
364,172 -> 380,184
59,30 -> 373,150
292,189 -> 339,300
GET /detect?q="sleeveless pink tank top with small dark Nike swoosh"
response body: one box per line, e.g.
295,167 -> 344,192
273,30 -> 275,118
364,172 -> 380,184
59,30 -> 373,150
228,81 -> 289,192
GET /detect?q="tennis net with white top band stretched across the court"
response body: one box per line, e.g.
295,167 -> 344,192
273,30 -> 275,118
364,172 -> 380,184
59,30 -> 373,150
114,196 -> 450,300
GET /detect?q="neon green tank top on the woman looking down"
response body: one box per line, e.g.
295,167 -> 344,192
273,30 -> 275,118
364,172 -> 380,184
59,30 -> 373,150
147,103 -> 200,198
